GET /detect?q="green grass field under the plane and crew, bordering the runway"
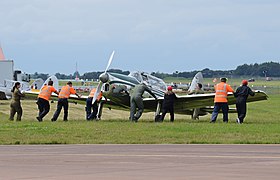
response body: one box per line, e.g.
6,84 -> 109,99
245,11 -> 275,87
0,94 -> 280,144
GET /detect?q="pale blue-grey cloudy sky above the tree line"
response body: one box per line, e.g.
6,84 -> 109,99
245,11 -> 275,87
0,0 -> 280,74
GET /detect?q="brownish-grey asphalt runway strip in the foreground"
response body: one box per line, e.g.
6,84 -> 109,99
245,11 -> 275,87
0,145 -> 280,180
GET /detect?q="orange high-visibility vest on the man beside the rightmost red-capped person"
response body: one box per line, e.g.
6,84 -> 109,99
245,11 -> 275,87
214,82 -> 234,103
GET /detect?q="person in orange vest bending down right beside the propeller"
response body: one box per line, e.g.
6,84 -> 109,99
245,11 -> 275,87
86,88 -> 102,121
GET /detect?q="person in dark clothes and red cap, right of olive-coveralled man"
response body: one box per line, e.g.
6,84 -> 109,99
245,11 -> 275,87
160,86 -> 177,122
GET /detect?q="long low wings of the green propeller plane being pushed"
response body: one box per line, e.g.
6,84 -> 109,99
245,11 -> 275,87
25,91 -> 268,114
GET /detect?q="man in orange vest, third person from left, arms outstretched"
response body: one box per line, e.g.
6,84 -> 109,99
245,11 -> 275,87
52,81 -> 80,121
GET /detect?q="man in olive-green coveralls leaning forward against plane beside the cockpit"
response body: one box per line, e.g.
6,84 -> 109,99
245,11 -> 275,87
129,81 -> 157,122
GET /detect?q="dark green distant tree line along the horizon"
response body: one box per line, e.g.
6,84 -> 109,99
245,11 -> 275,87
31,62 -> 280,80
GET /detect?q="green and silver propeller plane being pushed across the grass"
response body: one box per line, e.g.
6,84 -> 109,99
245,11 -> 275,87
25,51 -> 267,120
